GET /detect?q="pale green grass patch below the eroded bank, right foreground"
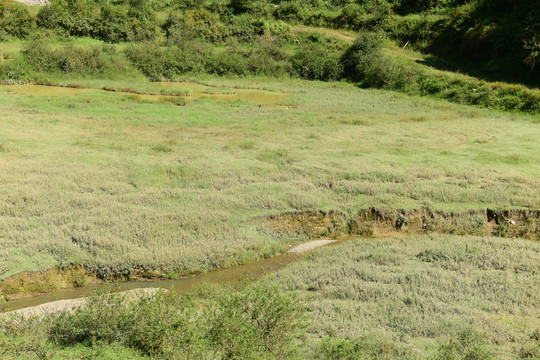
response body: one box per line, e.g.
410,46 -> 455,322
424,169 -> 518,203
269,235 -> 540,359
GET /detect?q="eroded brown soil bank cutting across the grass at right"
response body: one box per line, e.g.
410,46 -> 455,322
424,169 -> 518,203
267,208 -> 540,240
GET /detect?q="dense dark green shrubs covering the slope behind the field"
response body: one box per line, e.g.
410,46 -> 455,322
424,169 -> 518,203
0,0 -> 540,113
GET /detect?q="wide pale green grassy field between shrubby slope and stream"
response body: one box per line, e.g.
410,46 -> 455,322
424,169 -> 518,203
0,77 -> 540,279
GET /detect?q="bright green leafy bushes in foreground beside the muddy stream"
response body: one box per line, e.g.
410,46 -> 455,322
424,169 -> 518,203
48,284 -> 305,359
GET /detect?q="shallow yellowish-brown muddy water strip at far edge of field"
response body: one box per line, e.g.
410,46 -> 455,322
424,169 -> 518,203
0,82 -> 290,107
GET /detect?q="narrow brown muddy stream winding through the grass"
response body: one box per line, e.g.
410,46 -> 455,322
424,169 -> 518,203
7,253 -> 302,310
